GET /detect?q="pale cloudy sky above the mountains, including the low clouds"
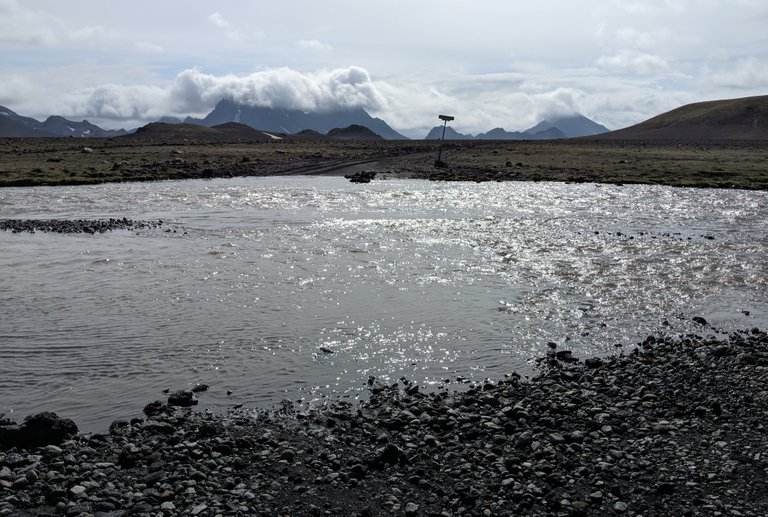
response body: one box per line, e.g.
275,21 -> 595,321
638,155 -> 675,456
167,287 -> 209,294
0,0 -> 768,138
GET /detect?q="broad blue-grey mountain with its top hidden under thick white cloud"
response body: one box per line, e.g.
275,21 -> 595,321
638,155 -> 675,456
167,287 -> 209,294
184,99 -> 408,140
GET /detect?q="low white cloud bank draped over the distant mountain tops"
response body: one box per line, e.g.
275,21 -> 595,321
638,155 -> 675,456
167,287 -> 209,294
7,66 -> 608,137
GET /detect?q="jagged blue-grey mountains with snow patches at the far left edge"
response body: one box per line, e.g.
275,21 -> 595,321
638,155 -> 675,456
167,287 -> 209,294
0,106 -> 126,138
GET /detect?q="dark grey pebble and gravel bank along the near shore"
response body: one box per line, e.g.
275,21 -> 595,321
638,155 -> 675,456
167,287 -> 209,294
0,329 -> 768,516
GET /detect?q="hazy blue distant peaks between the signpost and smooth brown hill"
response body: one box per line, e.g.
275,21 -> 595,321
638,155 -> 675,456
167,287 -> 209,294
425,115 -> 609,140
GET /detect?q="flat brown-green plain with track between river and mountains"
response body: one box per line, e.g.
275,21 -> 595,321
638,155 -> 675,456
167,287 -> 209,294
0,135 -> 768,190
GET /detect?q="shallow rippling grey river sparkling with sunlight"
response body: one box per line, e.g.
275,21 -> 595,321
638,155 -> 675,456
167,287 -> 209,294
0,177 -> 768,431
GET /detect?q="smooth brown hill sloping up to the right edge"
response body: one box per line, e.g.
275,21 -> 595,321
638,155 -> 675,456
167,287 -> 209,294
596,95 -> 768,141
